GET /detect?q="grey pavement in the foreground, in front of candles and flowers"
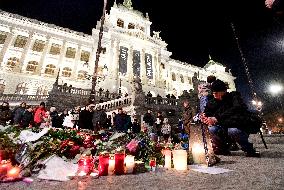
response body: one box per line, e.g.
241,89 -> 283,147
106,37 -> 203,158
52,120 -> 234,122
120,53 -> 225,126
0,135 -> 284,190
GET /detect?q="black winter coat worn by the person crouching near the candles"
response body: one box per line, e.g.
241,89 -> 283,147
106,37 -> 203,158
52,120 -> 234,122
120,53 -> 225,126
204,92 -> 253,131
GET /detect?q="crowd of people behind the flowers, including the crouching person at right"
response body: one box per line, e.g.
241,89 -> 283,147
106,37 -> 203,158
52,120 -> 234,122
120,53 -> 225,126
0,76 -> 260,157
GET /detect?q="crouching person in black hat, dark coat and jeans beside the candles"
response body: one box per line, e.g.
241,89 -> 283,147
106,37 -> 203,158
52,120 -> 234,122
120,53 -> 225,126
201,79 -> 260,157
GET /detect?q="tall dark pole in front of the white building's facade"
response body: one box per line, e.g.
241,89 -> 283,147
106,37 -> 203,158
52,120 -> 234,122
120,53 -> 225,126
90,0 -> 107,101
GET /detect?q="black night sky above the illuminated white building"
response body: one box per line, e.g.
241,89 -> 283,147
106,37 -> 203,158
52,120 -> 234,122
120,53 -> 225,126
0,0 -> 284,107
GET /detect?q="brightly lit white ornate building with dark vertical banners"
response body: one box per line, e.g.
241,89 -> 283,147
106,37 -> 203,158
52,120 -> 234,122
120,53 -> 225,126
0,1 -> 235,97
